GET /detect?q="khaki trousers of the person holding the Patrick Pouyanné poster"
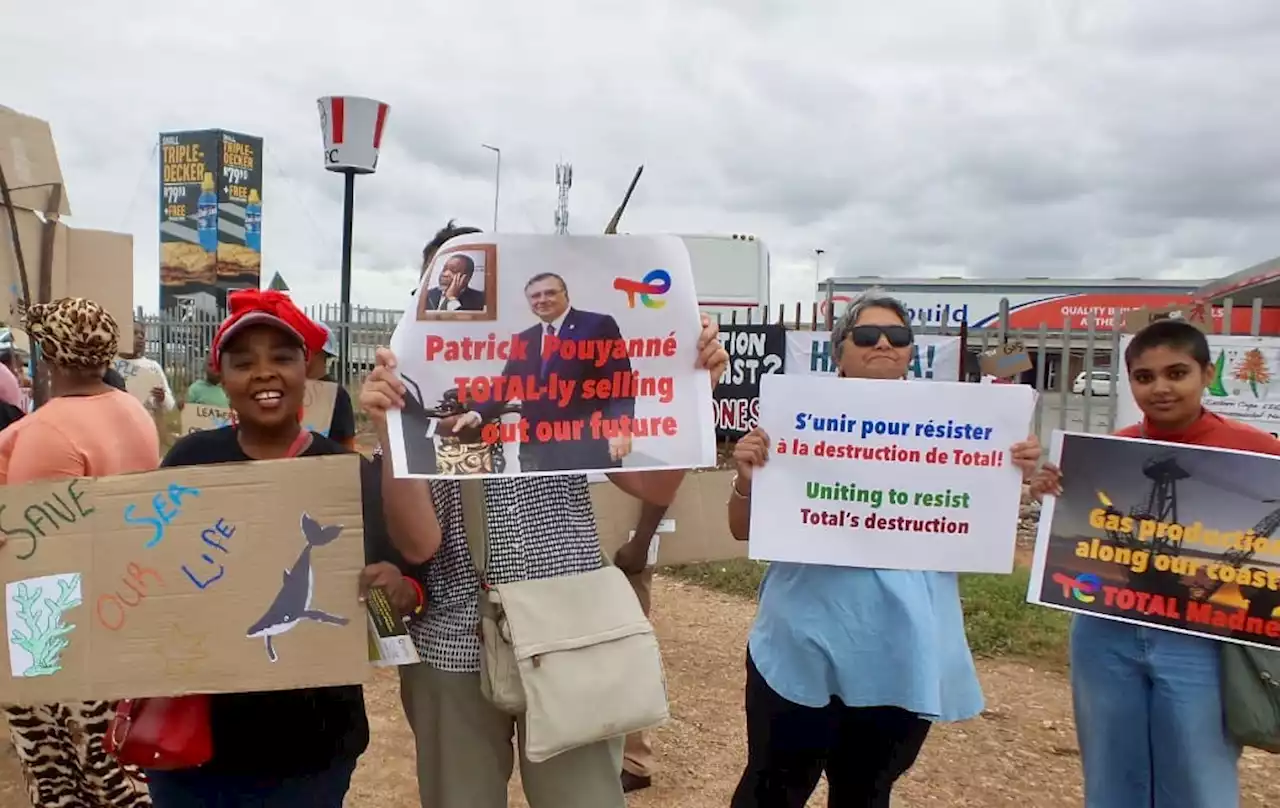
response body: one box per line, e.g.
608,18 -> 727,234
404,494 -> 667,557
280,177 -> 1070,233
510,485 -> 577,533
399,662 -> 626,808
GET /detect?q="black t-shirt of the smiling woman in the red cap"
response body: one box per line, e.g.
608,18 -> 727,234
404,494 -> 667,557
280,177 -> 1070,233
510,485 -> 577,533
161,426 -> 403,779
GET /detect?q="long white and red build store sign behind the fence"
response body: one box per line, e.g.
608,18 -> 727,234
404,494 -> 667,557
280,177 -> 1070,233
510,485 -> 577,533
818,289 -> 1280,333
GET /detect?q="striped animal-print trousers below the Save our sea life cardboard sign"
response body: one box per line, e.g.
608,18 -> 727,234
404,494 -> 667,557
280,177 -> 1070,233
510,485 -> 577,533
5,702 -> 151,808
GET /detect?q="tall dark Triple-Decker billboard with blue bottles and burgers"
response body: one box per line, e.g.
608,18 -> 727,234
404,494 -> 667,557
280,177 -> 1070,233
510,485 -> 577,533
160,129 -> 262,312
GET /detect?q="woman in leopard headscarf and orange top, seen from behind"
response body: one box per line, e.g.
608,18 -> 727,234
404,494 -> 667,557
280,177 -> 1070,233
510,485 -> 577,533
0,298 -> 160,808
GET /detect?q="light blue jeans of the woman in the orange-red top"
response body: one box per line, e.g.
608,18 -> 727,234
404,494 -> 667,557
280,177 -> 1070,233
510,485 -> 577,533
1071,616 -> 1240,808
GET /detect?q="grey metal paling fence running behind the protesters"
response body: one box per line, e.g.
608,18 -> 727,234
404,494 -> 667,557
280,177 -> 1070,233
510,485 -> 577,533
138,300 -> 1263,439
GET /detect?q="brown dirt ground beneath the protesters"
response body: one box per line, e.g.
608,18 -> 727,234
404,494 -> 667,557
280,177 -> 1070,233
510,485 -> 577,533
0,578 -> 1280,808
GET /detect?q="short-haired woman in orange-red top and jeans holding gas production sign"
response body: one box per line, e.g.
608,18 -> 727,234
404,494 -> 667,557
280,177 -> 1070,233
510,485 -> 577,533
1032,320 -> 1280,808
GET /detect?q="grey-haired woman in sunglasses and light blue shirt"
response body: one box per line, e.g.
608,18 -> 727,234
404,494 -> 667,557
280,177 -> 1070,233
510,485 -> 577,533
728,289 -> 1039,808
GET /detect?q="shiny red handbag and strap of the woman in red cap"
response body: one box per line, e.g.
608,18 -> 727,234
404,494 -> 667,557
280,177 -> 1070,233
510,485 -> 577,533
102,429 -> 311,771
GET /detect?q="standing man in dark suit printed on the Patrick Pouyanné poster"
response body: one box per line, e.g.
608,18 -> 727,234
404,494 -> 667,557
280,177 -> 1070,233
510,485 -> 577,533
440,273 -> 636,471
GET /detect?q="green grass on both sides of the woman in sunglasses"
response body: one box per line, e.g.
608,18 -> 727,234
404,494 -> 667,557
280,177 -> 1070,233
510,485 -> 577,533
664,558 -> 1068,665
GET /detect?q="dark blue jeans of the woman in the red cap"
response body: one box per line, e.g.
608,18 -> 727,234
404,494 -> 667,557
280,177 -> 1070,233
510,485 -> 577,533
147,761 -> 356,808
